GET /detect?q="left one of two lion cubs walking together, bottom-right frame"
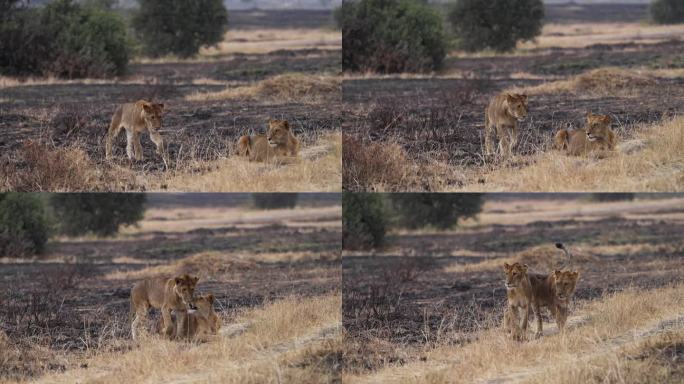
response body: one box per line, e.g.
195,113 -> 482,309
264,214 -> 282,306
504,263 -> 532,340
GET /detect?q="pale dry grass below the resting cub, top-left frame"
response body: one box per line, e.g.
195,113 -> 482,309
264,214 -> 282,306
160,132 -> 342,192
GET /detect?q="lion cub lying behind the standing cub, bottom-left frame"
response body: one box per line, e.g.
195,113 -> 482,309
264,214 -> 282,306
159,293 -> 221,341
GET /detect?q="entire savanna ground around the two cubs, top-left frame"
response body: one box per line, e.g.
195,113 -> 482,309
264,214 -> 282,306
0,10 -> 342,192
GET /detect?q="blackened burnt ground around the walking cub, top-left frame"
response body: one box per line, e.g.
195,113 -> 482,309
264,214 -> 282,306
0,10 -> 341,183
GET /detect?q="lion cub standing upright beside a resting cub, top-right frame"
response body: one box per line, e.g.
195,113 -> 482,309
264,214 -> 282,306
485,93 -> 527,157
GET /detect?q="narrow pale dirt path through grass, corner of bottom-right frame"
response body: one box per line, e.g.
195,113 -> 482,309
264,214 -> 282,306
478,313 -> 684,384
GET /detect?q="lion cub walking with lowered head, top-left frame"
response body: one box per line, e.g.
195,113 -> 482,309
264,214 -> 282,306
105,100 -> 165,160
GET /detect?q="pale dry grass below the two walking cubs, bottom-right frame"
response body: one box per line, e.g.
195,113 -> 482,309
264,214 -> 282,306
345,285 -> 684,383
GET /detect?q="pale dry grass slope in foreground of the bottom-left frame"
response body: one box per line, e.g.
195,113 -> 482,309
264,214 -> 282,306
27,294 -> 341,383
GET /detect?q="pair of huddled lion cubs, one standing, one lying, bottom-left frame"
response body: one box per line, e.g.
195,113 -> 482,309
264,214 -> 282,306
131,274 -> 221,341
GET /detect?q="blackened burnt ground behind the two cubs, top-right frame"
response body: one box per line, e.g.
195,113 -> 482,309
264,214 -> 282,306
342,5 -> 684,190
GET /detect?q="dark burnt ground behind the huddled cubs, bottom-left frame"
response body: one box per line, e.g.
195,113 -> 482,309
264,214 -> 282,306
0,212 -> 341,376
